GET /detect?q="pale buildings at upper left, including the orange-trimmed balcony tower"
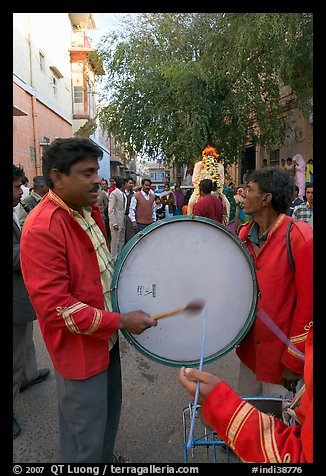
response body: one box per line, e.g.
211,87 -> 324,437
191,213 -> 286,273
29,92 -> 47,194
13,13 -> 116,183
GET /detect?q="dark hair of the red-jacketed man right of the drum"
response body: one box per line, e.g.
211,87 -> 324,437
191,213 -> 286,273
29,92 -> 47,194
248,167 -> 295,213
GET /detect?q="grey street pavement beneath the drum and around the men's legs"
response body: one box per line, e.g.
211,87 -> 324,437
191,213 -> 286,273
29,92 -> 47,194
13,321 -> 239,464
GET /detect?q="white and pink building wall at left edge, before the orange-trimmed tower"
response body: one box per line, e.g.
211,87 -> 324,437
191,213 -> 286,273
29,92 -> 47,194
13,13 -> 72,182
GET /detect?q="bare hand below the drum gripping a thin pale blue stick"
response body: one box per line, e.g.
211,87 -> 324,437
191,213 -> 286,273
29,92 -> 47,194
179,367 -> 221,404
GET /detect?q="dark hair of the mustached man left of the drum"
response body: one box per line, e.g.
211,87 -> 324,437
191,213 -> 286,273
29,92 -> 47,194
42,137 -> 103,188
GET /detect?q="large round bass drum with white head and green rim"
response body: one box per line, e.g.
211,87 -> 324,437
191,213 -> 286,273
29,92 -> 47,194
111,216 -> 257,367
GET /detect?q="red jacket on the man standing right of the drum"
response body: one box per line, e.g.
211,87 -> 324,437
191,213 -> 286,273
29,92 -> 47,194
236,214 -> 313,384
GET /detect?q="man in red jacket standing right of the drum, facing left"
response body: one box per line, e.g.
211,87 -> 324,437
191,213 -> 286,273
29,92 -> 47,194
236,167 -> 313,398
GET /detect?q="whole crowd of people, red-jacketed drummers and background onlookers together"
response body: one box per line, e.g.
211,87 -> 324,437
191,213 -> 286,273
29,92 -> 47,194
13,137 -> 313,463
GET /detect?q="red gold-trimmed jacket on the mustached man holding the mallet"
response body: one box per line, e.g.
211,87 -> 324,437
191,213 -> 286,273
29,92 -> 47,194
20,192 -> 120,380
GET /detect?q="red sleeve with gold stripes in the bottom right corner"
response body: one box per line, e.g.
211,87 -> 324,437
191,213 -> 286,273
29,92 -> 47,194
203,328 -> 313,463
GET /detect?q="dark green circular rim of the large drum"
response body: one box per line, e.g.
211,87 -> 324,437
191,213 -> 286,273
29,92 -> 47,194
110,215 -> 258,367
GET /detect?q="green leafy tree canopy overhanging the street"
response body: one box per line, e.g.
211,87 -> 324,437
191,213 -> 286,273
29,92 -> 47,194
99,13 -> 313,165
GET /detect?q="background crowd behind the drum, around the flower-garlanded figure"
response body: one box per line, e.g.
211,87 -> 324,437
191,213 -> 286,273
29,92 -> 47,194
98,151 -> 313,244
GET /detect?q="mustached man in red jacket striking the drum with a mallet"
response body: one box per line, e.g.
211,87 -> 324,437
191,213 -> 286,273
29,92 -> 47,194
21,137 -> 157,463
